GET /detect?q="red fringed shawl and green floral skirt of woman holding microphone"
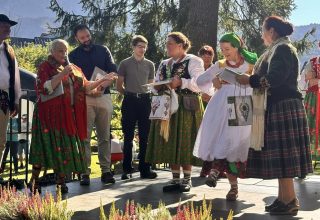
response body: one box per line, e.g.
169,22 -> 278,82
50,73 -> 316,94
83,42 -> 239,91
29,56 -> 87,174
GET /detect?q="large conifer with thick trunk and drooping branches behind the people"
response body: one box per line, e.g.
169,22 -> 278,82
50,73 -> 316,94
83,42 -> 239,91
50,0 -> 313,63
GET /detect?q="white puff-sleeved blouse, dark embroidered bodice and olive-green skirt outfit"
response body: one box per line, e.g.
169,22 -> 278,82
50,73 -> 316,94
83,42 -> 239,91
146,54 -> 204,165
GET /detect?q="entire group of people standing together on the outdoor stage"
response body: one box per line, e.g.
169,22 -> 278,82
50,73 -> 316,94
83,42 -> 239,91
0,12 -> 320,215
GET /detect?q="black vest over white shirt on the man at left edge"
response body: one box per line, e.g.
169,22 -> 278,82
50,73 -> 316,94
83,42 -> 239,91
3,41 -> 16,111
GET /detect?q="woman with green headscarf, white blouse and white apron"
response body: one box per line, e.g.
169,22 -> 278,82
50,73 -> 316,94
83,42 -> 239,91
193,33 -> 257,201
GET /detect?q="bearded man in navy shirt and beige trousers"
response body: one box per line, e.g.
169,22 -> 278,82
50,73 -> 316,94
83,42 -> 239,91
69,25 -> 117,185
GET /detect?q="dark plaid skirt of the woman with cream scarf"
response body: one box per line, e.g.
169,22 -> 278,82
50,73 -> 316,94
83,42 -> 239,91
247,99 -> 312,179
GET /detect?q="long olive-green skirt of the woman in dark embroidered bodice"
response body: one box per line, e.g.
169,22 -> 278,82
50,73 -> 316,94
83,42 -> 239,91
145,95 -> 203,166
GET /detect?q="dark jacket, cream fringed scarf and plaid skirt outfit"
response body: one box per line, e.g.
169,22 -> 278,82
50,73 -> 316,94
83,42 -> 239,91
247,37 -> 312,179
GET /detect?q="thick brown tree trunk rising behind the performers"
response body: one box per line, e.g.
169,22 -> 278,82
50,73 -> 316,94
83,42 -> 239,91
180,0 -> 220,59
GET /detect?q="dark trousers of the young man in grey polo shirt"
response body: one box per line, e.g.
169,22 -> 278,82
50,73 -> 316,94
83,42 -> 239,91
121,95 -> 151,173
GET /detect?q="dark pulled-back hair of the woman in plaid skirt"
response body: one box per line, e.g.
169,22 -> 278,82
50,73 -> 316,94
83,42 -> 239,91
264,16 -> 293,37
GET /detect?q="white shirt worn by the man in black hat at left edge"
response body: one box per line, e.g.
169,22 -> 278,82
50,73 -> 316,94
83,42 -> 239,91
0,42 -> 21,104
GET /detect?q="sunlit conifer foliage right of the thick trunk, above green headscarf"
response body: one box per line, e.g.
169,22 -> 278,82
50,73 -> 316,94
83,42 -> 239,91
219,0 -> 296,54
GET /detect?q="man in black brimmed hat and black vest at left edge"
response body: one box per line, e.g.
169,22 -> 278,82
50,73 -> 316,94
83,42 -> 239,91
0,14 -> 21,181
